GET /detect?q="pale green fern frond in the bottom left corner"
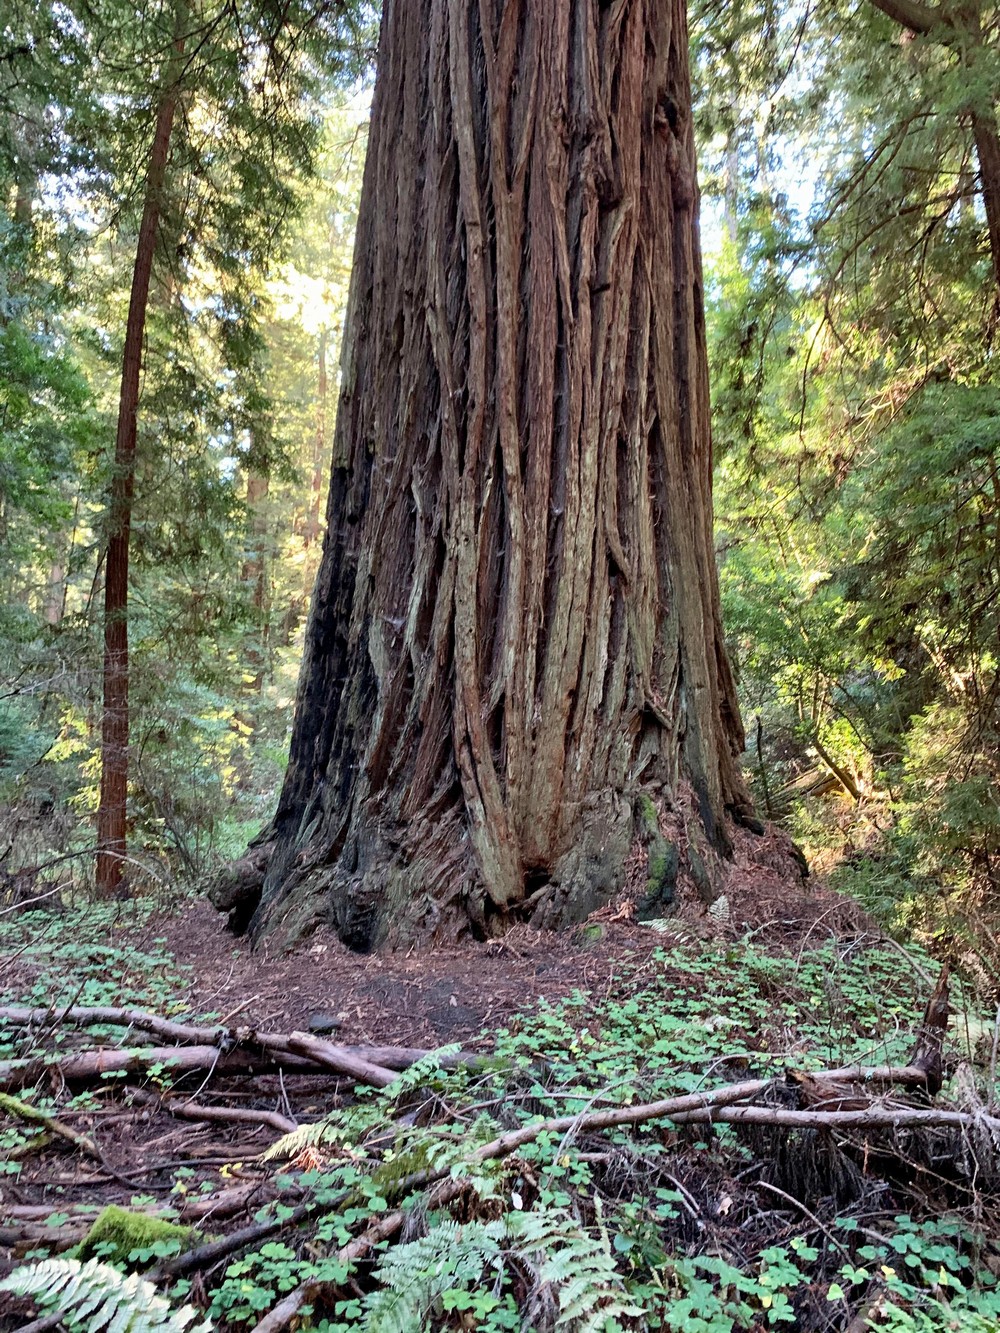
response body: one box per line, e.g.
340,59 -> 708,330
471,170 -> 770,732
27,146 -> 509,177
0,1258 -> 211,1333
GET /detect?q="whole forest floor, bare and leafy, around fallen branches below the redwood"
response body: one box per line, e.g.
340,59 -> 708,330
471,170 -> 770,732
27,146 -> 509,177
0,892 -> 1000,1333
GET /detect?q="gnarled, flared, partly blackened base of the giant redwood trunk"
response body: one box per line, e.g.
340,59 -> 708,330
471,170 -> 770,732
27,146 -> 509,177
217,784 -> 801,953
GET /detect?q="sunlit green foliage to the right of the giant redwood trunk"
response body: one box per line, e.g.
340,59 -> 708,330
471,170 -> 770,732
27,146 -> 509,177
695,4 -> 1000,950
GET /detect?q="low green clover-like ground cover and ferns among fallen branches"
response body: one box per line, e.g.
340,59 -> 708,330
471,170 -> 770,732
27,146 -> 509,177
4,917 -> 999,1333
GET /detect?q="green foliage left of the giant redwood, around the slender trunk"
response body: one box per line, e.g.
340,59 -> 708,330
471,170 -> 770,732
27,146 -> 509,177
0,0 -> 376,890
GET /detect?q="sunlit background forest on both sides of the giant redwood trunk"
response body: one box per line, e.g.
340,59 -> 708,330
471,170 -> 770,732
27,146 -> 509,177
0,0 -> 1000,952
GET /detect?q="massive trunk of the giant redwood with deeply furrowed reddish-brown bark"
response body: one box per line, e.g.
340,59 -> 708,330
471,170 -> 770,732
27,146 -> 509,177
253,0 -> 747,948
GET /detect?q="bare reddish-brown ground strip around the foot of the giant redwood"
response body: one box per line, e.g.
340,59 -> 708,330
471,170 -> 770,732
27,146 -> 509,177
117,886 -> 864,1048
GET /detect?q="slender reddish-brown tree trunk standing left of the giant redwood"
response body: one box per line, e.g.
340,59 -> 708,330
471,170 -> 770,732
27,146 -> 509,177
96,15 -> 184,894
